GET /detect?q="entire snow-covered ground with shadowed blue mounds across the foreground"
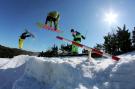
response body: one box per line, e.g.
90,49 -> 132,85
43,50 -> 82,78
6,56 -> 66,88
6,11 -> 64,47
0,51 -> 135,89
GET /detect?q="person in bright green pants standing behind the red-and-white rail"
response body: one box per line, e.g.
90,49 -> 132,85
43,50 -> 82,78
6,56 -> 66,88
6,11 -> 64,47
71,29 -> 85,54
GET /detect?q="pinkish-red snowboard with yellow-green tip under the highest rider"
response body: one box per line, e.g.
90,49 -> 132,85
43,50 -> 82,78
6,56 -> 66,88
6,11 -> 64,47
37,22 -> 62,33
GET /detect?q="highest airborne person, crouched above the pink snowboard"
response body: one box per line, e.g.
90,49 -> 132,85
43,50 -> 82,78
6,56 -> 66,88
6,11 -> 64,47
45,11 -> 60,30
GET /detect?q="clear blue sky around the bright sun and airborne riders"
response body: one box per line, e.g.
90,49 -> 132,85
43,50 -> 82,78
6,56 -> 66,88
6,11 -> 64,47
0,0 -> 135,51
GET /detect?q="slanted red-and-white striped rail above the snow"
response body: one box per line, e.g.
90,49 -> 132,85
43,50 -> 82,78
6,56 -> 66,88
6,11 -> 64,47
56,36 -> 120,61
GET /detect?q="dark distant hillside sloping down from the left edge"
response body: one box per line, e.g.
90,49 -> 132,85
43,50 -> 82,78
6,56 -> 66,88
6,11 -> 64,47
0,45 -> 39,58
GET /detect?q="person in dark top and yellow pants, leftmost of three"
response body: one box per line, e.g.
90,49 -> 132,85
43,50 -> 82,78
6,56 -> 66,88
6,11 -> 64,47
19,30 -> 34,49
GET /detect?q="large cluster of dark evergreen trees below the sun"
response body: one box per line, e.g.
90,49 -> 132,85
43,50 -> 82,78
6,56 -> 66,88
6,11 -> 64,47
95,24 -> 135,55
